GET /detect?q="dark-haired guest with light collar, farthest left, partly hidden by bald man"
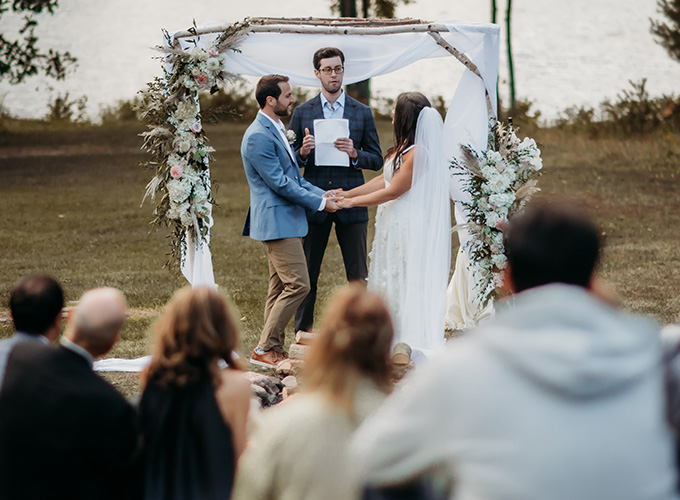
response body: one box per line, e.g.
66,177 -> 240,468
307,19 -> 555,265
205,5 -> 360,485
0,274 -> 64,388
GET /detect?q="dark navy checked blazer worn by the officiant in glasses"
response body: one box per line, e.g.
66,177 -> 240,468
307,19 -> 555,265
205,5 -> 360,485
289,95 -> 383,224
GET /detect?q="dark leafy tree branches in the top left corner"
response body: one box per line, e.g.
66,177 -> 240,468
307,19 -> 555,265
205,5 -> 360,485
0,0 -> 76,84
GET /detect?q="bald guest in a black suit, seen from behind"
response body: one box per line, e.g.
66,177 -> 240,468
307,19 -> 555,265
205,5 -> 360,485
0,288 -> 137,500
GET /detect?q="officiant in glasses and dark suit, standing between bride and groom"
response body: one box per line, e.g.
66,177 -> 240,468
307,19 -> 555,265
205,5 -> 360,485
290,47 -> 383,331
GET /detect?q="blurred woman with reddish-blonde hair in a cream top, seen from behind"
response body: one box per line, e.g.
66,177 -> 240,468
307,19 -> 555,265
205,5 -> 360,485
234,283 -> 393,500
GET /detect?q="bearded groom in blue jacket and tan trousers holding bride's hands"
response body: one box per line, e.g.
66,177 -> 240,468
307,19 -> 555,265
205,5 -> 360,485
241,75 -> 338,367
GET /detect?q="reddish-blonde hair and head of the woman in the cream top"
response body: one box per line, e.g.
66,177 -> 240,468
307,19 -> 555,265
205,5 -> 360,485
305,283 -> 393,411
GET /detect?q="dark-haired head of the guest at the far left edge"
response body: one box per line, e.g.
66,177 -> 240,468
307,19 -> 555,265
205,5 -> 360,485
9,274 -> 64,340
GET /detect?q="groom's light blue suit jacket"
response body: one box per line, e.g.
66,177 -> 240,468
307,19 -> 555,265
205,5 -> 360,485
241,113 -> 324,241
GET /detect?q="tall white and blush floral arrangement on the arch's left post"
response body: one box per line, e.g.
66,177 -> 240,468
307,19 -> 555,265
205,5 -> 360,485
140,22 -> 249,265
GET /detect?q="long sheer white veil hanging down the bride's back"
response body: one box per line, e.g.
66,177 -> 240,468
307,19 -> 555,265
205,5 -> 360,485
403,107 -> 451,350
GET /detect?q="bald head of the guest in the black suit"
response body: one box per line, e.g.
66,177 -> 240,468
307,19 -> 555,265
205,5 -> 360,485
64,288 -> 126,357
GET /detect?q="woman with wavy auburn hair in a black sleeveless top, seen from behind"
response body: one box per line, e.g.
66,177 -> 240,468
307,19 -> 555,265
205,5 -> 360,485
139,287 -> 252,500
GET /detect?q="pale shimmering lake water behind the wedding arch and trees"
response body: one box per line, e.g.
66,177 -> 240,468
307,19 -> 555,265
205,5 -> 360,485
0,0 -> 680,119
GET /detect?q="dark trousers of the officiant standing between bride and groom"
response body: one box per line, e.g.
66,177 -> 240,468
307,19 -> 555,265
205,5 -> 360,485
295,213 -> 368,331
